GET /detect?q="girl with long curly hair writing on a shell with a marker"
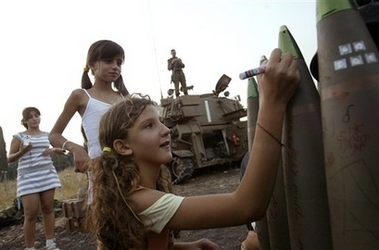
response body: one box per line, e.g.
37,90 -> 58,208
88,49 -> 300,250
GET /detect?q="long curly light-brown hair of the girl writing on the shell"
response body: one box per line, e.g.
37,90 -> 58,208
87,94 -> 172,250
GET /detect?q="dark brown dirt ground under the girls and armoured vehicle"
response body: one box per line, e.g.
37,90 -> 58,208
0,166 -> 247,250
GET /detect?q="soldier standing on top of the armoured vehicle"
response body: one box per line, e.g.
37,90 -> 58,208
167,49 -> 188,97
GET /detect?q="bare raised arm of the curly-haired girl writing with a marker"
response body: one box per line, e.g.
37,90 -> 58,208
133,49 -> 300,230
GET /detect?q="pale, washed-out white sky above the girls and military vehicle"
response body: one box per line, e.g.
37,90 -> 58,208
0,0 -> 317,152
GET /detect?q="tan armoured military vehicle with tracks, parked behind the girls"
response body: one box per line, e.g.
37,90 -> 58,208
160,75 -> 248,184
